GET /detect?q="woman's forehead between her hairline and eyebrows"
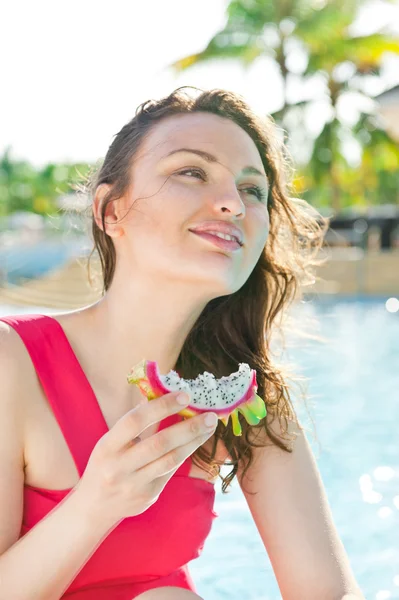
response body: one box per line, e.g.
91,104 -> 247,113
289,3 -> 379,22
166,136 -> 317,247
139,112 -> 264,172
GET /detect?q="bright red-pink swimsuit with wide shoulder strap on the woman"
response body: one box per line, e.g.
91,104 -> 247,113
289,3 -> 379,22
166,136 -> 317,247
0,314 -> 219,600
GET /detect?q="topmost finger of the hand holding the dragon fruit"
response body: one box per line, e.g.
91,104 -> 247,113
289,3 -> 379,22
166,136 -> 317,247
104,392 -> 191,453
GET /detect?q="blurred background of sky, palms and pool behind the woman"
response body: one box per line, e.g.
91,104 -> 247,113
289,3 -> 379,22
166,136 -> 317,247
0,0 -> 399,600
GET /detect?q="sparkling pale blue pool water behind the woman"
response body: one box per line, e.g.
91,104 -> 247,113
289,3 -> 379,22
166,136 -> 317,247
0,298 -> 399,600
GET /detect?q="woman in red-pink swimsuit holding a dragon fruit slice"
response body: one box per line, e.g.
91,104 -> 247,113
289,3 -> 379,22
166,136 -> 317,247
0,89 -> 363,600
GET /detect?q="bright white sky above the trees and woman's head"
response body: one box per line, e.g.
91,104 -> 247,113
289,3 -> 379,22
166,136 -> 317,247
0,0 -> 399,166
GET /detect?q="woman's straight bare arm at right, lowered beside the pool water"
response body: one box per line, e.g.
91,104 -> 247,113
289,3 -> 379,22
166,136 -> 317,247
238,422 -> 364,600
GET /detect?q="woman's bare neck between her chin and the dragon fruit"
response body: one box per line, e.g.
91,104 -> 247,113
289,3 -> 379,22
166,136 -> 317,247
79,268 -> 209,391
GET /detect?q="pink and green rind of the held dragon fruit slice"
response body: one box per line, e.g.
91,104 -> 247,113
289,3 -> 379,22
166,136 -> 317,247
127,359 -> 267,435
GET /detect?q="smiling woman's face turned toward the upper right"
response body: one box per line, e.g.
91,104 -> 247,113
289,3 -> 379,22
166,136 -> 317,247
107,112 -> 269,301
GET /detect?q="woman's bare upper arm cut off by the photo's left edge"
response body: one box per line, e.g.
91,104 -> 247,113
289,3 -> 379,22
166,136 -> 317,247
0,322 -> 26,554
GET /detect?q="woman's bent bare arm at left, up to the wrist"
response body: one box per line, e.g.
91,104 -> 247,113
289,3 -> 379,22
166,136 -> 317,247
0,324 -> 118,600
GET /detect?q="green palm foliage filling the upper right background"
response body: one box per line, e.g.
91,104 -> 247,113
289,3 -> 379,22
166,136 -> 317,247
170,0 -> 399,211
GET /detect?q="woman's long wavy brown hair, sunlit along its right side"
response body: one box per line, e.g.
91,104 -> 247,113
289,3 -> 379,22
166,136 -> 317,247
84,86 -> 329,493
